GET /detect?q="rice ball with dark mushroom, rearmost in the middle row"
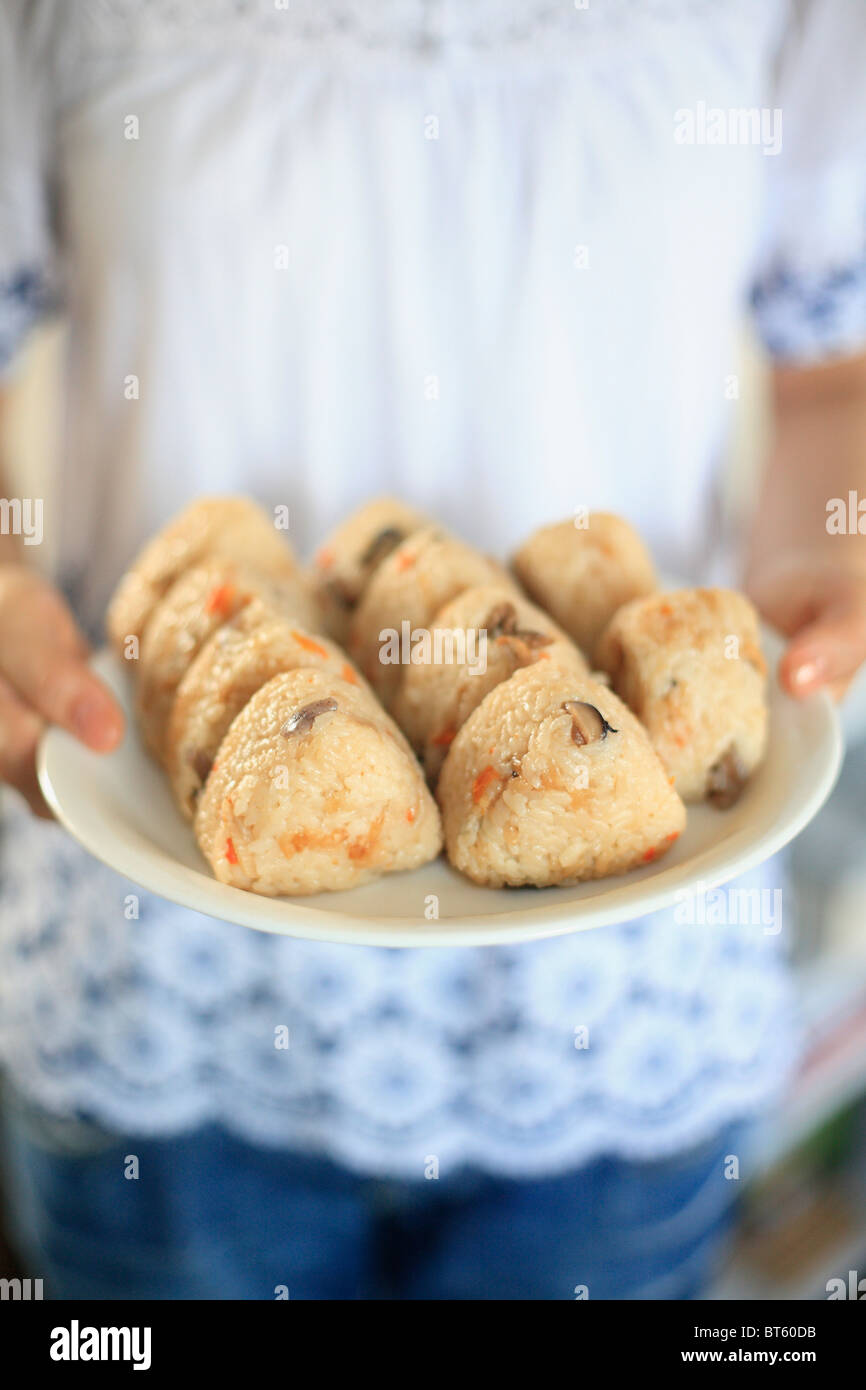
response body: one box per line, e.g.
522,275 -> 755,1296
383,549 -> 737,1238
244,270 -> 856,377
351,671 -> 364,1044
311,498 -> 430,646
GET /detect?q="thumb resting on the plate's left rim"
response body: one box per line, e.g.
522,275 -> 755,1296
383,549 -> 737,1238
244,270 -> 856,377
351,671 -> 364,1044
3,641 -> 124,753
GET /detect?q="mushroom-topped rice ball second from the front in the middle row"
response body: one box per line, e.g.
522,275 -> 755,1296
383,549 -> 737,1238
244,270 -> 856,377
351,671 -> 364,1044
393,584 -> 589,783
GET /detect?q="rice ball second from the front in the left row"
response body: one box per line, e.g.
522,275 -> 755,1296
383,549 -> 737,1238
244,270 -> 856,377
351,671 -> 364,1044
165,599 -> 366,819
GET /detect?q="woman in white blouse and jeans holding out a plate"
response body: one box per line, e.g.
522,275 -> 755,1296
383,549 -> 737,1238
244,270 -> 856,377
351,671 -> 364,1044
0,0 -> 866,1298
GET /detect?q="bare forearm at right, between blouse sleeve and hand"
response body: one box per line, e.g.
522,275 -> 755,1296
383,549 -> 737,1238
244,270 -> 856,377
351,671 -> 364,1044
748,356 -> 866,580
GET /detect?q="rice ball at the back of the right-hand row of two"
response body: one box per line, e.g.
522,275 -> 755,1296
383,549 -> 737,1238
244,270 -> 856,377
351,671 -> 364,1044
513,512 -> 657,660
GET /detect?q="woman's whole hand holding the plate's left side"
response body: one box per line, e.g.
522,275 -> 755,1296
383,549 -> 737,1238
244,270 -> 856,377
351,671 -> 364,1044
0,564 -> 124,817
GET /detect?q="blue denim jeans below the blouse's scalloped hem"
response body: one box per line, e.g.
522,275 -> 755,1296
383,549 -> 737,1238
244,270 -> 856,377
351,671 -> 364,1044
3,1098 -> 737,1300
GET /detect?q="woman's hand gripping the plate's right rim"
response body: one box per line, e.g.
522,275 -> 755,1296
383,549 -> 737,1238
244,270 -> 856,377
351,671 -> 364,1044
746,552 -> 866,699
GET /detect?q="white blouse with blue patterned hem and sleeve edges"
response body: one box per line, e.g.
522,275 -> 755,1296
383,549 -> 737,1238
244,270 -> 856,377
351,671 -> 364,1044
0,0 -> 866,1176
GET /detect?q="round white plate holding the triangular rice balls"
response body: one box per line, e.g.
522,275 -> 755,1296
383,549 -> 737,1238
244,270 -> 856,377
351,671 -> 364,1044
39,632 -> 842,947
